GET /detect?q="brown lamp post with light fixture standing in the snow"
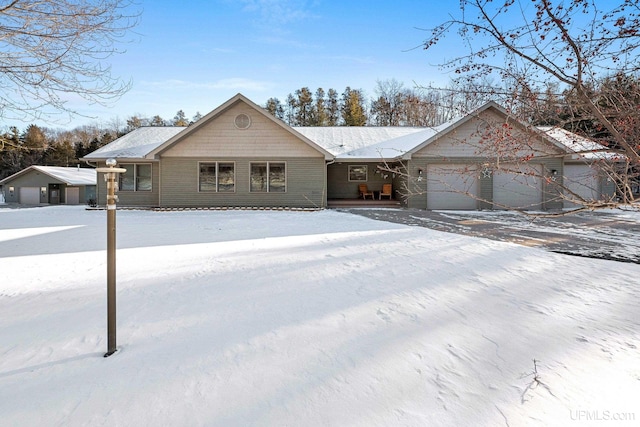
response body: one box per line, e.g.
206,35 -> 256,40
96,159 -> 127,357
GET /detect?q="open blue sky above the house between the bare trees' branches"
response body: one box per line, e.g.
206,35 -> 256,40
23,0 -> 459,128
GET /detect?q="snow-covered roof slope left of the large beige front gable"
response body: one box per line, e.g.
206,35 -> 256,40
83,126 -> 187,160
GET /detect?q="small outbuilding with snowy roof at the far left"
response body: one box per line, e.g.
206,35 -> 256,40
0,165 -> 97,205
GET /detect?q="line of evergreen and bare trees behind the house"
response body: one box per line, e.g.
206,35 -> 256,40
0,74 -> 640,179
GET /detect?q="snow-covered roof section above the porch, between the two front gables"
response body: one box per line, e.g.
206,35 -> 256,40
293,126 -> 425,157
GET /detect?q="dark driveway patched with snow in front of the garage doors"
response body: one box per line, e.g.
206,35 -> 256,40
342,208 -> 640,264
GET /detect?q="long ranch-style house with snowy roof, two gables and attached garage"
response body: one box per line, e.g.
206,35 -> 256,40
82,94 -> 612,210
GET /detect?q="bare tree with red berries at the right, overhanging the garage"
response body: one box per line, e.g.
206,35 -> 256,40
424,0 -> 640,208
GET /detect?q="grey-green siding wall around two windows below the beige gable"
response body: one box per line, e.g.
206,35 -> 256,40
161,159 -> 326,208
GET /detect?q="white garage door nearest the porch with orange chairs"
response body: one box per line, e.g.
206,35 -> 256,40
427,165 -> 478,210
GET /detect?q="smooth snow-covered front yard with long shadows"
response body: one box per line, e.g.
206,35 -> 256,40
0,206 -> 640,426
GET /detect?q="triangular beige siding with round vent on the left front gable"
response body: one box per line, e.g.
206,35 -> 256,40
162,103 -> 322,159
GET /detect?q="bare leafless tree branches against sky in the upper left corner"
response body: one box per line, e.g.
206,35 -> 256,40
0,0 -> 138,130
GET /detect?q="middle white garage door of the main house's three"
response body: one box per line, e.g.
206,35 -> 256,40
493,165 -> 543,210
